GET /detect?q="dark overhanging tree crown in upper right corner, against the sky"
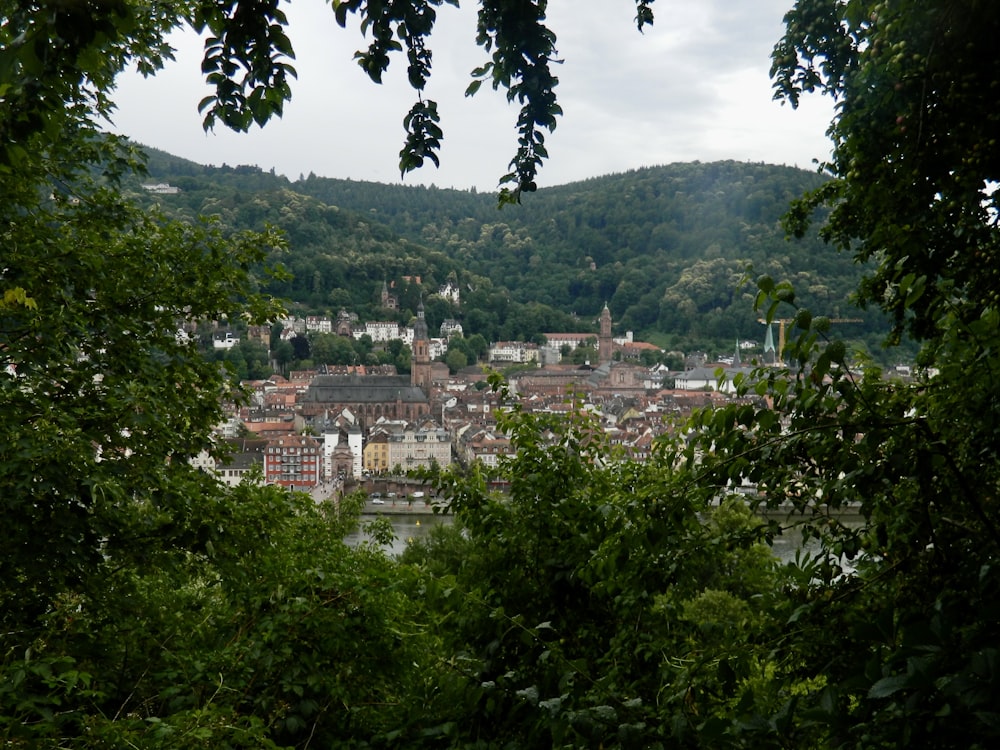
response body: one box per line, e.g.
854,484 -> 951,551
774,2 -> 1000,346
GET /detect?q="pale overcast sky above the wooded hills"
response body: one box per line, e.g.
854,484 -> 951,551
110,0 -> 833,191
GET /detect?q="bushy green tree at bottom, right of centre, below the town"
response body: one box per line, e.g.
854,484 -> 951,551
404,384 -> 792,747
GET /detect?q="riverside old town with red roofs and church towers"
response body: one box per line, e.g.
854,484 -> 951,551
195,296 -> 812,499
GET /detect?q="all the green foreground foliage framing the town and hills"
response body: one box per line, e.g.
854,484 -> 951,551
0,0 -> 1000,748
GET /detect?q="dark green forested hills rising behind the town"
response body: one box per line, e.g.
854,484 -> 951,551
137,151 -> 883,356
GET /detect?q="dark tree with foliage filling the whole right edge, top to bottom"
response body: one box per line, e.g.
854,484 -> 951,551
664,0 -> 1000,747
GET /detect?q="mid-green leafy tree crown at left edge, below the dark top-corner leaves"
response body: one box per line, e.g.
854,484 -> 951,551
0,178 -> 280,617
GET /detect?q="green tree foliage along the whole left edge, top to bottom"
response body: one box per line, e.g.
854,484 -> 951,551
0,42 -> 328,746
